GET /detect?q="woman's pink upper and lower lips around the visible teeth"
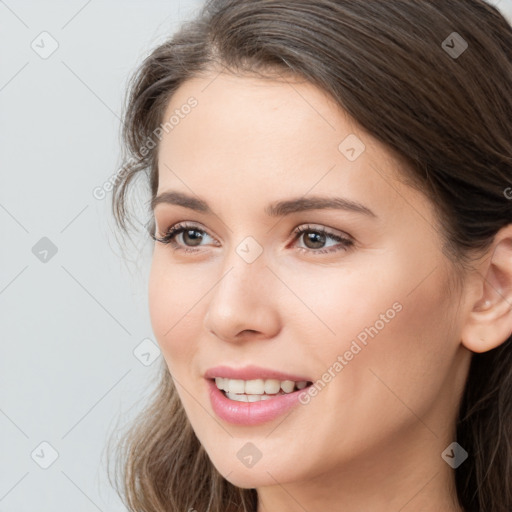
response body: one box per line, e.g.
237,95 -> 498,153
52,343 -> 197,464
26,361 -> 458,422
205,366 -> 311,426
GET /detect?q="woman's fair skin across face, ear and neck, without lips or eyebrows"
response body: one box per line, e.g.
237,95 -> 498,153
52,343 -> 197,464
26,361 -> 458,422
149,73 -> 512,512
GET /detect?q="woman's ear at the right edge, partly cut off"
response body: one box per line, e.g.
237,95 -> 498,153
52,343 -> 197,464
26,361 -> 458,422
461,224 -> 512,352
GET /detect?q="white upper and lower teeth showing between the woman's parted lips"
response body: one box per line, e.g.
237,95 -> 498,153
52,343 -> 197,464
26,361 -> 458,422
211,377 -> 312,402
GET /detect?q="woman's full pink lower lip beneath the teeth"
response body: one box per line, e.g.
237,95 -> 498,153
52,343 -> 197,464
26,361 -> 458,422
208,380 -> 304,425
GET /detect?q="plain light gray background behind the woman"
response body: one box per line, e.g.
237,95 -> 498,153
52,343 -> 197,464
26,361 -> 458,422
0,0 -> 512,512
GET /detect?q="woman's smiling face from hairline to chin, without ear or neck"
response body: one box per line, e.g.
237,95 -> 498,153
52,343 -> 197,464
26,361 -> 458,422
149,74 -> 470,487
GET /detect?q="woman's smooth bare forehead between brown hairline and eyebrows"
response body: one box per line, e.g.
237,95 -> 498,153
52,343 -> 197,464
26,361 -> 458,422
158,73 -> 420,221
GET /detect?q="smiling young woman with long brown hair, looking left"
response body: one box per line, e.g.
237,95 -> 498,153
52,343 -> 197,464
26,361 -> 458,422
106,0 -> 512,512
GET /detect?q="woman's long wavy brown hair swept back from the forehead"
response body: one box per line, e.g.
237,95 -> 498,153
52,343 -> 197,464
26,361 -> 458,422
109,0 -> 512,512
